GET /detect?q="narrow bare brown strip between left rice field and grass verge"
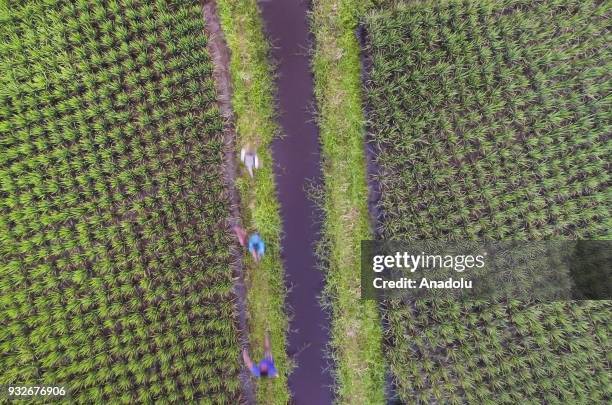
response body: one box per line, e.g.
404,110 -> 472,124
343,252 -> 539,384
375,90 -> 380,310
201,0 -> 255,405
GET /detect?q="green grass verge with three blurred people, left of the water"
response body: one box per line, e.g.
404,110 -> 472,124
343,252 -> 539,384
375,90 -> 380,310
217,0 -> 292,404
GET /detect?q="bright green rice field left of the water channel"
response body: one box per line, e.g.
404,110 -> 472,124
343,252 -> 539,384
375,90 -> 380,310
0,0 -> 241,403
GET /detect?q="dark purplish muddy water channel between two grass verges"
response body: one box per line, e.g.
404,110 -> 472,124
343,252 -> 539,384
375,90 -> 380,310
259,0 -> 332,405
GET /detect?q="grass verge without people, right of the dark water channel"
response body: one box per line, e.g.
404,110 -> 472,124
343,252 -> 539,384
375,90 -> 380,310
312,0 -> 385,404
